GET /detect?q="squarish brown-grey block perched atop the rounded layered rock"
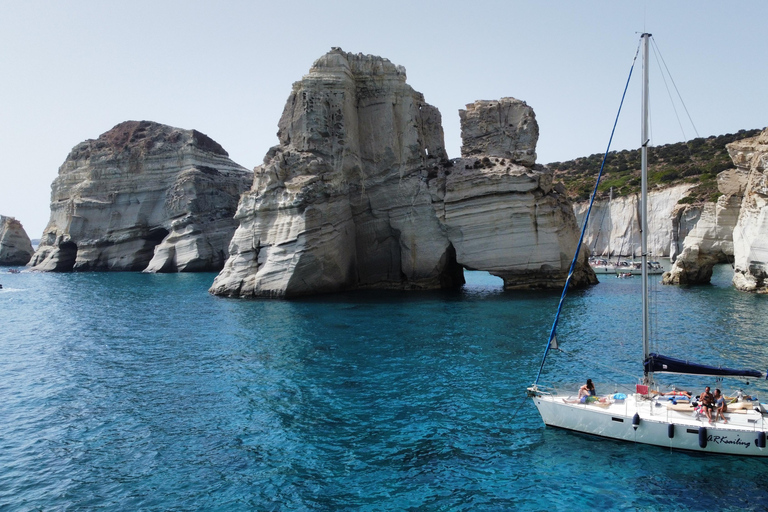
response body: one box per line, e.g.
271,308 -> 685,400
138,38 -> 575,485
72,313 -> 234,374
459,98 -> 539,167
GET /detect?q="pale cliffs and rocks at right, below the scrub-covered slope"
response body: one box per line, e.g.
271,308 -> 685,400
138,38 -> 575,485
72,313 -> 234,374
574,129 -> 768,293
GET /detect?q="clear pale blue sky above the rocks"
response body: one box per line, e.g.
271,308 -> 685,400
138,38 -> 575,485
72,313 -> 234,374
0,0 -> 768,238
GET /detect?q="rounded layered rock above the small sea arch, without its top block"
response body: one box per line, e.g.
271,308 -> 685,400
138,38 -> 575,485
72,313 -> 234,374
436,156 -> 597,289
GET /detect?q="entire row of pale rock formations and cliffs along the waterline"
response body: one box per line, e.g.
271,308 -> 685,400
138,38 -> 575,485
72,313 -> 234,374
7,48 -> 768,298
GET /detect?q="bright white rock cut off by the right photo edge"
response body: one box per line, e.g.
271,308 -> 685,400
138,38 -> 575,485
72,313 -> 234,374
727,128 -> 768,293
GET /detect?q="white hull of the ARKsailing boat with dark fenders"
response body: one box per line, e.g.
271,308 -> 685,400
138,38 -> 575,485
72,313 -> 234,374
533,395 -> 768,457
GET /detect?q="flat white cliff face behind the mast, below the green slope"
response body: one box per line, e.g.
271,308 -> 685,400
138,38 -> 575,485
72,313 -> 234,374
574,184 -> 693,259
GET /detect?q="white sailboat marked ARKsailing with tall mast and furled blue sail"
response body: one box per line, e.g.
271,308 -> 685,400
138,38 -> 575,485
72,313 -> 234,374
528,33 -> 768,457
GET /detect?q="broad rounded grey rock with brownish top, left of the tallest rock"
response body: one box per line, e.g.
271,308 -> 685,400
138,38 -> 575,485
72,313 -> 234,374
30,121 -> 252,272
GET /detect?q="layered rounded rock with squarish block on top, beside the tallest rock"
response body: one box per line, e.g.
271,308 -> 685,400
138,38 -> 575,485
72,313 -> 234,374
438,98 -> 597,289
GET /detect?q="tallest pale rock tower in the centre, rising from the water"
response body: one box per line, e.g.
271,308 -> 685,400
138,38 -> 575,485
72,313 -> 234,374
211,49 -> 462,297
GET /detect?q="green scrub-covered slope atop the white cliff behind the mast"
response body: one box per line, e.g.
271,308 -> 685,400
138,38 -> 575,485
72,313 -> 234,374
548,130 -> 760,203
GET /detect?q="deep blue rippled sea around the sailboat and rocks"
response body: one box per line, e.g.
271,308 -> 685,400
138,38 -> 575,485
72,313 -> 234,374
0,266 -> 768,511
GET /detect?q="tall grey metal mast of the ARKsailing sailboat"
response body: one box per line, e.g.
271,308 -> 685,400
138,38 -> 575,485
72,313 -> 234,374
640,33 -> 653,384
